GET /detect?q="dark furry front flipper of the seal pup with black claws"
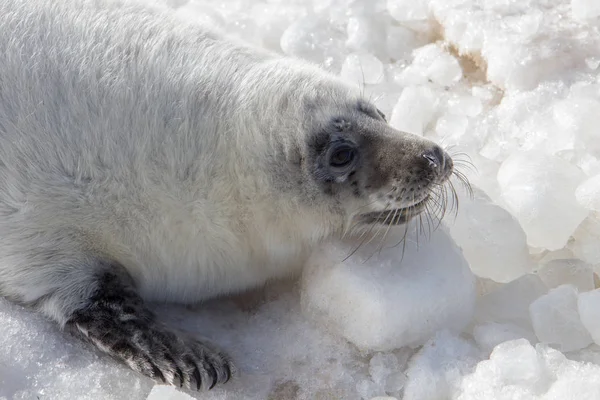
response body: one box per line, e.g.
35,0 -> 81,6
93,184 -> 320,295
67,265 -> 234,390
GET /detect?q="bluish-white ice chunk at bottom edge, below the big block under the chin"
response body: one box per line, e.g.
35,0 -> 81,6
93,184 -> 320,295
403,331 -> 481,400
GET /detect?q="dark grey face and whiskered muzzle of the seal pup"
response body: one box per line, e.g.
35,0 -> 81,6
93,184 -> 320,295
306,96 -> 453,233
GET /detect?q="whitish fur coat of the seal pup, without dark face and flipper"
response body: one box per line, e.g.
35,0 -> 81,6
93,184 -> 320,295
0,0 -> 372,322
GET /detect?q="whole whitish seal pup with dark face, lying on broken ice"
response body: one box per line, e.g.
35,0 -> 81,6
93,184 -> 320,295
0,0 -> 453,390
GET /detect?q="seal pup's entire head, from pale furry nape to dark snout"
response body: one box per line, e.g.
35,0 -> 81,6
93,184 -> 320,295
239,66 -> 454,244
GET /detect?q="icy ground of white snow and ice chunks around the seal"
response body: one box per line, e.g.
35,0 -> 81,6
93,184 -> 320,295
0,0 -> 600,400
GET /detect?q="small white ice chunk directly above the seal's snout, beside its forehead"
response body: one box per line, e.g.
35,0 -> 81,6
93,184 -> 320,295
390,86 -> 437,135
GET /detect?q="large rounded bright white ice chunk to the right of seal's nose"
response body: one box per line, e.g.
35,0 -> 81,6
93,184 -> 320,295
498,151 -> 588,250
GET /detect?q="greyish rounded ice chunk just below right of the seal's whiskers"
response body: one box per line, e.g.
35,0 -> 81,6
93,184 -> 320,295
448,189 -> 533,282
